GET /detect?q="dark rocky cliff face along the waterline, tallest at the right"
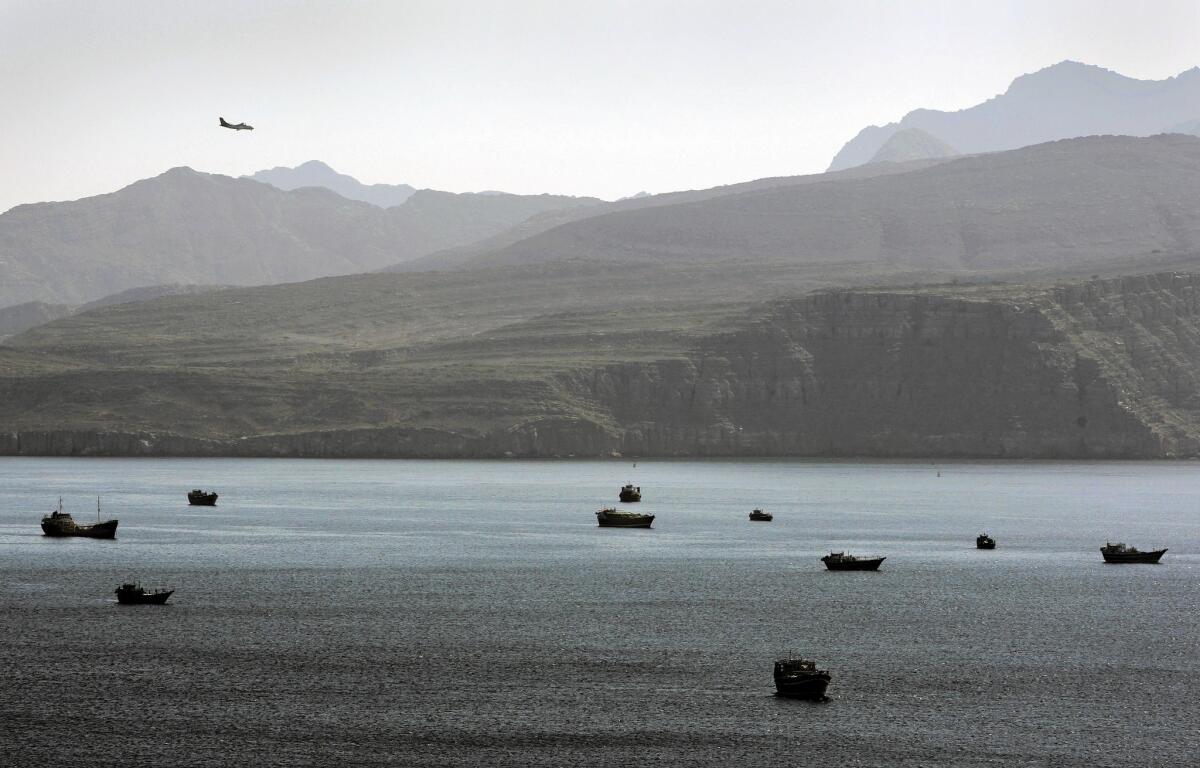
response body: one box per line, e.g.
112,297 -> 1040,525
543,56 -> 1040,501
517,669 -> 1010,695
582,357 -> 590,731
7,274 -> 1200,458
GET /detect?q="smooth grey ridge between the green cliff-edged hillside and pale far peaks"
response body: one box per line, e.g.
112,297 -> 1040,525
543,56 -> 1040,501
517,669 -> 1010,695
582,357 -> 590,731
451,134 -> 1200,274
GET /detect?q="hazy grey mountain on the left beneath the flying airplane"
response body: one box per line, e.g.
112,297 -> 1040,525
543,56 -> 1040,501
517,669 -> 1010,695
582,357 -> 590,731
0,168 -> 599,307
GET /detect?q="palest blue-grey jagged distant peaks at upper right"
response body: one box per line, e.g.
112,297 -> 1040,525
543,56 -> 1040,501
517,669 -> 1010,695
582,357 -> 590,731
829,61 -> 1200,170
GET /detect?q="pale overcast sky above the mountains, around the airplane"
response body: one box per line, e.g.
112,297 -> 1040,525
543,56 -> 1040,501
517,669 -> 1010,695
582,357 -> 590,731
0,0 -> 1200,211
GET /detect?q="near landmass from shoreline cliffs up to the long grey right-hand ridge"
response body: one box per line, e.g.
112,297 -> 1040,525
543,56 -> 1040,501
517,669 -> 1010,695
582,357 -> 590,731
7,136 -> 1200,457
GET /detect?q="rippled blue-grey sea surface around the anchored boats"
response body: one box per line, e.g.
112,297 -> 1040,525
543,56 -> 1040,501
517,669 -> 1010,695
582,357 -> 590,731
0,458 -> 1200,767
